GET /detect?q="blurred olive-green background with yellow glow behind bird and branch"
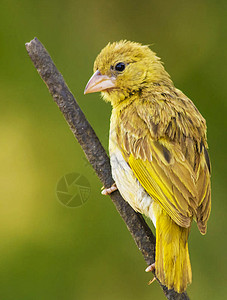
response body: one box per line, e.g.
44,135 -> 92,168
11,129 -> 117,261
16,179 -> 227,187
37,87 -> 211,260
0,0 -> 227,300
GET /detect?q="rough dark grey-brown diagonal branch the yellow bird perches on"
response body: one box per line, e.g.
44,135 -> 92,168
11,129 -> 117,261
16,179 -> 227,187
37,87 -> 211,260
25,38 -> 189,300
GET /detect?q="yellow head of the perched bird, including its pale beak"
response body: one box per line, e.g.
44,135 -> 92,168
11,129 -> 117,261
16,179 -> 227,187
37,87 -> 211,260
84,41 -> 170,105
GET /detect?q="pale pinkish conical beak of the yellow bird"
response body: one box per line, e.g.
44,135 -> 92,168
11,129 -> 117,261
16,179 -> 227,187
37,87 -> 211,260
84,70 -> 115,94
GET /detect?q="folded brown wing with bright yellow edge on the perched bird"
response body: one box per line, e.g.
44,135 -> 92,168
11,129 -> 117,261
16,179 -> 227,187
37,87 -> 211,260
118,95 -> 211,234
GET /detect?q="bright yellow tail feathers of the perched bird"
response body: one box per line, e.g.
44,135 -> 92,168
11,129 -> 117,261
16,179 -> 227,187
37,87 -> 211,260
155,209 -> 192,293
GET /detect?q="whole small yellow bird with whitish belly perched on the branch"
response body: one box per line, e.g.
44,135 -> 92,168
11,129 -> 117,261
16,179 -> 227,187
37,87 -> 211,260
85,41 -> 211,293
